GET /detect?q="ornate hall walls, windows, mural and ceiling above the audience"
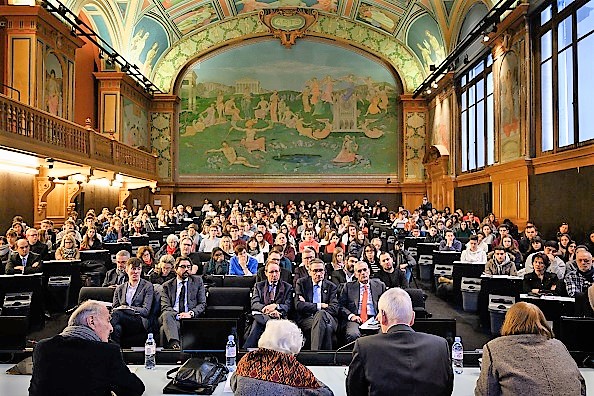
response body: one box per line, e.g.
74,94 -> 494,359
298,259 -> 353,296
0,0 -> 594,392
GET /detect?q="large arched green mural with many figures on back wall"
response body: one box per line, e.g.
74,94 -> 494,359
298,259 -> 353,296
178,40 -> 401,175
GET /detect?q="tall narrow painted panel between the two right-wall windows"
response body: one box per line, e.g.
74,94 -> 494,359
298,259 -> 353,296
499,51 -> 521,162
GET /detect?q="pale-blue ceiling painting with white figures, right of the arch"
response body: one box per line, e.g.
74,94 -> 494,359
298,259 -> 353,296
406,14 -> 445,72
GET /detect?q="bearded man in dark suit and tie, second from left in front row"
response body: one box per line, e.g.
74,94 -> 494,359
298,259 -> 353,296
159,257 -> 206,350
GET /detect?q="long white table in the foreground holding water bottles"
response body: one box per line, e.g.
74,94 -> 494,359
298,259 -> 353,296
0,364 -> 594,396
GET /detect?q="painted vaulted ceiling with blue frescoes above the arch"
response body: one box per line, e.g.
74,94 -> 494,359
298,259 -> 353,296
66,0 -> 493,90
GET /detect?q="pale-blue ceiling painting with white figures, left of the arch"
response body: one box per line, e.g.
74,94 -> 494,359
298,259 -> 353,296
126,17 -> 169,76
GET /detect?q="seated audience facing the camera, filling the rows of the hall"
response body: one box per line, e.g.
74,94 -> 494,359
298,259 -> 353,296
0,198 -> 594,350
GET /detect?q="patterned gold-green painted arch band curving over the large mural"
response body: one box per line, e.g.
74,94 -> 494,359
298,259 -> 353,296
151,13 -> 424,93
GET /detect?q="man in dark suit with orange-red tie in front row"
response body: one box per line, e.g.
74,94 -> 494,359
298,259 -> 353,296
338,261 -> 386,343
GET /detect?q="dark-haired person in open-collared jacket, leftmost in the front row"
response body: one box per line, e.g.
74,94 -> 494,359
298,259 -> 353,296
111,257 -> 154,344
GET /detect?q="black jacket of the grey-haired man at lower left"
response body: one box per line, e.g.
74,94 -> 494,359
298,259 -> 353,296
29,335 -> 144,396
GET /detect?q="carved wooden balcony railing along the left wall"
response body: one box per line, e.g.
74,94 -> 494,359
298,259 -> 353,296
0,94 -> 157,178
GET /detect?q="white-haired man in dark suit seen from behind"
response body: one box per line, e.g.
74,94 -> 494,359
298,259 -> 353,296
346,288 -> 454,396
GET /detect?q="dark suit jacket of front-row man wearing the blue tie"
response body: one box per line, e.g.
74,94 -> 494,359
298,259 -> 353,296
295,276 -> 339,321
